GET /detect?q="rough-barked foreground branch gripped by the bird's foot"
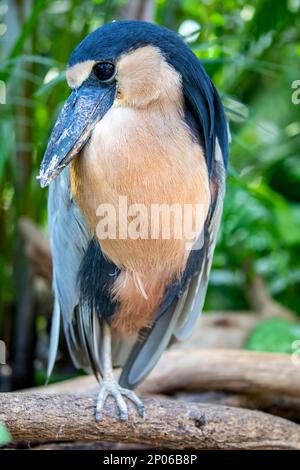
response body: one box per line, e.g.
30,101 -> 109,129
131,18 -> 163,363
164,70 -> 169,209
0,393 -> 300,449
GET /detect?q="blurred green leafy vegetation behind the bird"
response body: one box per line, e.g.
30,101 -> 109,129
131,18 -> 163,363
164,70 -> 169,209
0,0 -> 300,388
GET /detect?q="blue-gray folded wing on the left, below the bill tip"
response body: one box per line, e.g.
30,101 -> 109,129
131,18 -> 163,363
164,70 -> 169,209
48,168 -> 91,376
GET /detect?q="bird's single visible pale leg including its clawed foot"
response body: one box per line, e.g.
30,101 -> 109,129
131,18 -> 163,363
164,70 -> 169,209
96,320 -> 144,421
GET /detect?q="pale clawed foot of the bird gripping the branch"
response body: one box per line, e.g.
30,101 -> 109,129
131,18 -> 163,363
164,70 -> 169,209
96,379 -> 145,421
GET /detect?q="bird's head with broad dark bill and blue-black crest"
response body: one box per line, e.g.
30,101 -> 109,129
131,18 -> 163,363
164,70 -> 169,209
38,21 -> 227,187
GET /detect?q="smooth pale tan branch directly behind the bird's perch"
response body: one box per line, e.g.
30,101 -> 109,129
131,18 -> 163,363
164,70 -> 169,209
26,349 -> 300,398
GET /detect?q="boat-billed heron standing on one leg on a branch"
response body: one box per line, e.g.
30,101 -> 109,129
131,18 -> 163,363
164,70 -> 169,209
37,20 -> 229,421
